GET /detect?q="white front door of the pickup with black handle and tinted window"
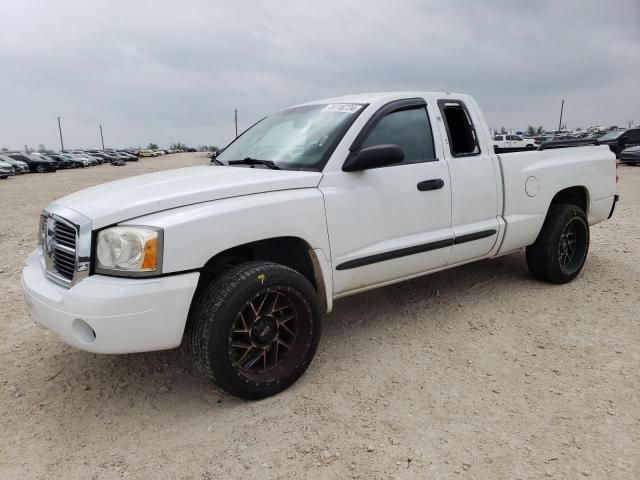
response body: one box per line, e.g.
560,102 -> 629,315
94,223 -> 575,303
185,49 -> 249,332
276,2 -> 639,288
319,99 -> 453,296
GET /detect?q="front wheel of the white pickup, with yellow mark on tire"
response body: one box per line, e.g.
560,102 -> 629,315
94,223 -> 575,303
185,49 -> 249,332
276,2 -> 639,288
189,262 -> 322,400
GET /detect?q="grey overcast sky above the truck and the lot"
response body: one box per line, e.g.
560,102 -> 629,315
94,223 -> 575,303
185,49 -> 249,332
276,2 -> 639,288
0,0 -> 640,148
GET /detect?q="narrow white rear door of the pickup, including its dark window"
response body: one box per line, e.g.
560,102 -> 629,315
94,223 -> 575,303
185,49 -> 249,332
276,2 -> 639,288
438,99 -> 502,265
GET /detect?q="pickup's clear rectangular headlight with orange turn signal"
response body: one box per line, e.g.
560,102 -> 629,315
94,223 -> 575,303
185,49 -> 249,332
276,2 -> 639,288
95,226 -> 162,276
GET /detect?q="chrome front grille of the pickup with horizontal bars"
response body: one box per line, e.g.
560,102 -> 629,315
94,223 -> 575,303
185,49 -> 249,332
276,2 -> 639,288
39,205 -> 91,287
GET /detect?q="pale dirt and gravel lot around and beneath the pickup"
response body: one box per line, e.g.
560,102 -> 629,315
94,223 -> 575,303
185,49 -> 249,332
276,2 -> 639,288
0,154 -> 640,479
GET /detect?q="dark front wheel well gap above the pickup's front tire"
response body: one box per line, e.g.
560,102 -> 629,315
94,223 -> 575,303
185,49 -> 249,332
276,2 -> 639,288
196,237 -> 318,292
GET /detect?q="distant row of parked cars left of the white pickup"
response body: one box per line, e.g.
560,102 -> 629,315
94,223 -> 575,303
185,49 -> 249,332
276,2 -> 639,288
0,148 -> 195,178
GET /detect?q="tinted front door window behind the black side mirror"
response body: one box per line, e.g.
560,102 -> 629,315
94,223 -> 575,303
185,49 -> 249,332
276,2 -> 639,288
362,107 -> 435,163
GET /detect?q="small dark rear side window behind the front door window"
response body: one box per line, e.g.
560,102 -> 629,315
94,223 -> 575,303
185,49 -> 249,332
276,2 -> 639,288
438,100 -> 480,157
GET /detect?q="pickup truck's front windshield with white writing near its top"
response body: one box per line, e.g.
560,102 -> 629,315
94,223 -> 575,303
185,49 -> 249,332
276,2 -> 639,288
216,103 -> 366,171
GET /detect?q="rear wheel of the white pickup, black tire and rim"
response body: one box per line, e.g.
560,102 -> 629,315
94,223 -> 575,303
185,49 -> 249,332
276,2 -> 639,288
527,205 -> 589,284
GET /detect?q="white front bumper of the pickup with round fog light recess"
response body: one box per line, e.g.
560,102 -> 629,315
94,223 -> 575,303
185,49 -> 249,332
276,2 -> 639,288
22,252 -> 200,353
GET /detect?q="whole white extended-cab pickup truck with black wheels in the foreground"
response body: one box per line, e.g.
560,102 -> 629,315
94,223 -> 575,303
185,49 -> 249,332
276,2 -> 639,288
22,92 -> 617,399
